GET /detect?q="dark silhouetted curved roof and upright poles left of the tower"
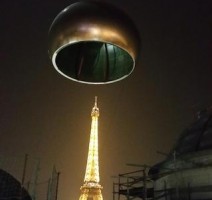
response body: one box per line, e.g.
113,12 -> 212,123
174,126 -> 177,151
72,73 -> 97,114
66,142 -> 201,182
0,154 -> 60,200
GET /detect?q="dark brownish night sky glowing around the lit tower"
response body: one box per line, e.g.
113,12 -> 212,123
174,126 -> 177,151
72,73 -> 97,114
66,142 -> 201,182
0,0 -> 212,200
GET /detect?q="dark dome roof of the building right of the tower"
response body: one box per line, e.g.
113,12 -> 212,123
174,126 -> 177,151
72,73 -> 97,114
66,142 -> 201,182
149,108 -> 212,178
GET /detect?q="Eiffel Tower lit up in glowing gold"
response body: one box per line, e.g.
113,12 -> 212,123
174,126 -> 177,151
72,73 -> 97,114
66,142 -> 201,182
79,97 -> 103,200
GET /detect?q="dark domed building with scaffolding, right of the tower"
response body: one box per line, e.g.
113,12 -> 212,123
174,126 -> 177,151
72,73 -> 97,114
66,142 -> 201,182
114,108 -> 212,200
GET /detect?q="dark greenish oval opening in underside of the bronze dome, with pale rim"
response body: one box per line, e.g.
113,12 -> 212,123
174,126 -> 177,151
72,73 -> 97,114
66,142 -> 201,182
55,42 -> 134,83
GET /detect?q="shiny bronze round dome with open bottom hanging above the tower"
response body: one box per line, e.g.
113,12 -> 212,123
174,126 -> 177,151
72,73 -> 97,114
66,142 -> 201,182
49,2 -> 140,84
